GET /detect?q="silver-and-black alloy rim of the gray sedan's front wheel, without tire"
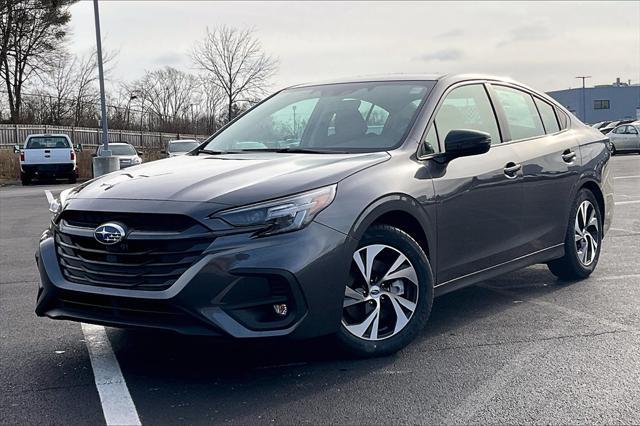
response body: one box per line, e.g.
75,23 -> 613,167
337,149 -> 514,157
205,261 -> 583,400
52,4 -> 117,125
342,244 -> 419,341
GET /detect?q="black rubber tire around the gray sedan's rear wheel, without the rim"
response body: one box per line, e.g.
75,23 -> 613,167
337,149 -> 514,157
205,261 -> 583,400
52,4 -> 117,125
547,188 -> 603,281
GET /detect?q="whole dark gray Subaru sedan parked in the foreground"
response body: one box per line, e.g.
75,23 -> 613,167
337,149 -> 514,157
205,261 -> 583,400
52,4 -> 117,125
36,75 -> 614,356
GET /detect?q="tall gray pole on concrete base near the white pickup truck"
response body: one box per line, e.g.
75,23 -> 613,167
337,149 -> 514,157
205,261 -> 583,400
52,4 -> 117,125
93,0 -> 120,177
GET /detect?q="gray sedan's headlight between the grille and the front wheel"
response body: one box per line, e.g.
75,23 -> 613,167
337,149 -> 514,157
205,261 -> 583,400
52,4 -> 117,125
213,185 -> 336,235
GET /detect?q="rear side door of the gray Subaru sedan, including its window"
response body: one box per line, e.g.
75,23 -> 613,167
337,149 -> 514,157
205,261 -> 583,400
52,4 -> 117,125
491,85 -> 581,254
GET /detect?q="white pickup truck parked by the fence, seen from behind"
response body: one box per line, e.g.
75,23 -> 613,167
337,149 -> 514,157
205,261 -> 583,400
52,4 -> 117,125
16,134 -> 78,185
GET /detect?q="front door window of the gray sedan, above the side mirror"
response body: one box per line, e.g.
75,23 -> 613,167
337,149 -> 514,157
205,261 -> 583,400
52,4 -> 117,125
432,84 -> 501,146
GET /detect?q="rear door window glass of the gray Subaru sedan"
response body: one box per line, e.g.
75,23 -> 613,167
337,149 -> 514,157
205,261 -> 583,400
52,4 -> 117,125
493,86 -> 545,140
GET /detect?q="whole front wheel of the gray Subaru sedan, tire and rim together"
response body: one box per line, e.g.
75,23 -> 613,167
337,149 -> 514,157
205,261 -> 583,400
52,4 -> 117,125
337,225 -> 433,356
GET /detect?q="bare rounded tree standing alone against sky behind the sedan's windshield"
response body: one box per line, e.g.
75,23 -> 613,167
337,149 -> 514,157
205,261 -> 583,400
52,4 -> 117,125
191,26 -> 278,121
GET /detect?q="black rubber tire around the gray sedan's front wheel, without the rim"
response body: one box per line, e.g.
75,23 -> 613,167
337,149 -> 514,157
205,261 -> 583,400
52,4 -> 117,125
336,225 -> 434,357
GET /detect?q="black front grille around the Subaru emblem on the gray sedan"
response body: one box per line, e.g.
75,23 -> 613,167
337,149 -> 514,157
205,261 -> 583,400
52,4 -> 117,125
55,211 -> 213,291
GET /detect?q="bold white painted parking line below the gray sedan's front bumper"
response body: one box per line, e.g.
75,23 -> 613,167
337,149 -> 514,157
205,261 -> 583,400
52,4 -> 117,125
82,323 -> 140,425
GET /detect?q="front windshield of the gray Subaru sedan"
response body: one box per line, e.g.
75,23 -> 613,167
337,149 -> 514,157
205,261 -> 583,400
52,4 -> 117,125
202,81 -> 435,152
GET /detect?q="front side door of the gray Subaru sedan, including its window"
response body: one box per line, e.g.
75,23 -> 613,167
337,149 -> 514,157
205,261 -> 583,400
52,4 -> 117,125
425,83 -> 522,284
